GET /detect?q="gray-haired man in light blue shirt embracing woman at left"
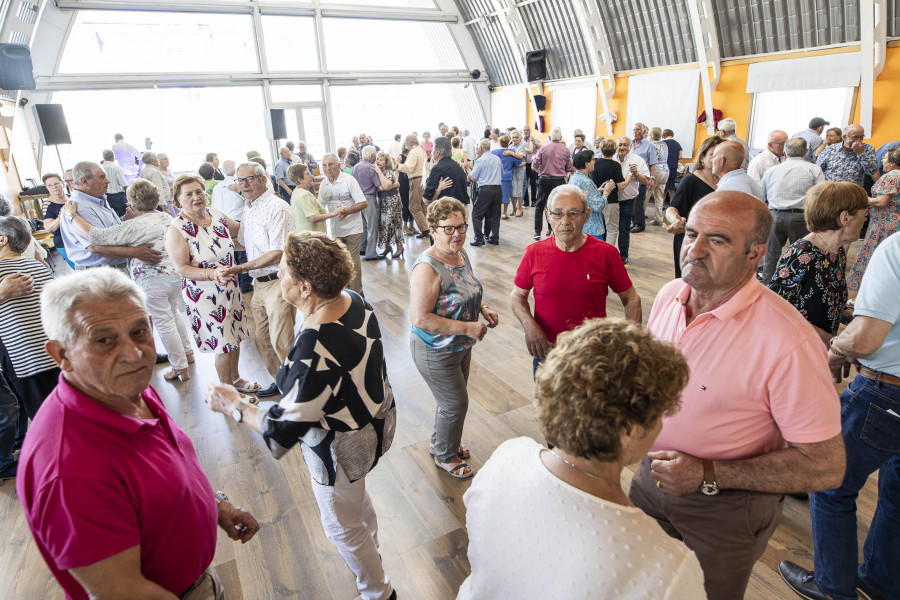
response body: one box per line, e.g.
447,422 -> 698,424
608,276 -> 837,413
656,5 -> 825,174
60,161 -> 162,272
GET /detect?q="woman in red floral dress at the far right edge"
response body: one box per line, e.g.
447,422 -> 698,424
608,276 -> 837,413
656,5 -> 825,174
847,146 -> 900,291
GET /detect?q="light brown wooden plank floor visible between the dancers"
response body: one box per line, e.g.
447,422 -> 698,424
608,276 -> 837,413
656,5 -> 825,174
0,209 -> 877,600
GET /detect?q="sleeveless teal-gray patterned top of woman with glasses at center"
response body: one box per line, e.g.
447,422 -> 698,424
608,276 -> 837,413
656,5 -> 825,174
412,250 -> 484,352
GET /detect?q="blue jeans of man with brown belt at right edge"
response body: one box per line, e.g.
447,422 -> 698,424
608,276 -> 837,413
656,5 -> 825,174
810,375 -> 900,600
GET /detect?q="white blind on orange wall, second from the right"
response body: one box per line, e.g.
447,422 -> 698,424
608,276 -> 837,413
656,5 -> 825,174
626,69 -> 700,158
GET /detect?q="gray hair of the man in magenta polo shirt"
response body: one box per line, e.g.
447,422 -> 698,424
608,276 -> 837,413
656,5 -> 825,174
41,267 -> 147,348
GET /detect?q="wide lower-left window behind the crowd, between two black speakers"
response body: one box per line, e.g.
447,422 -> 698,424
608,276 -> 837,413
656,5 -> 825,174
44,87 -> 271,173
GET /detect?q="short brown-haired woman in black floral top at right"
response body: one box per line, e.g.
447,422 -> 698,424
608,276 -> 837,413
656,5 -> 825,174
768,181 -> 869,345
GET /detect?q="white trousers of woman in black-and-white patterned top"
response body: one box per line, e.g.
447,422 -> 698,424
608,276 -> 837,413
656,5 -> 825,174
312,467 -> 393,600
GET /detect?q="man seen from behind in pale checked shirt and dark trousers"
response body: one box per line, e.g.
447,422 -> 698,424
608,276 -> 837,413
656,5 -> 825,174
762,138 -> 825,284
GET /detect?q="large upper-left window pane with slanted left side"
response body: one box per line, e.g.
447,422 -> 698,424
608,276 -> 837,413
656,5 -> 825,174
59,10 -> 259,74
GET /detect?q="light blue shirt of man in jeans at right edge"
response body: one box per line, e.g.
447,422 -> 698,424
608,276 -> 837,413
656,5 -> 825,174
853,235 -> 900,377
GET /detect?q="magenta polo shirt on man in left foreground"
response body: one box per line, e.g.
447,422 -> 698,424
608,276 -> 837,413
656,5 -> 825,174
16,375 -> 217,600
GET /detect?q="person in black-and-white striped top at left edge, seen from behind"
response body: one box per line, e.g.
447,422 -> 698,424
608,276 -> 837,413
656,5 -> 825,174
0,216 -> 59,422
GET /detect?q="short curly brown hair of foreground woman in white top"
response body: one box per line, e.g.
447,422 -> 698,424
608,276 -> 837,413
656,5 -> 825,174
535,319 -> 689,461
